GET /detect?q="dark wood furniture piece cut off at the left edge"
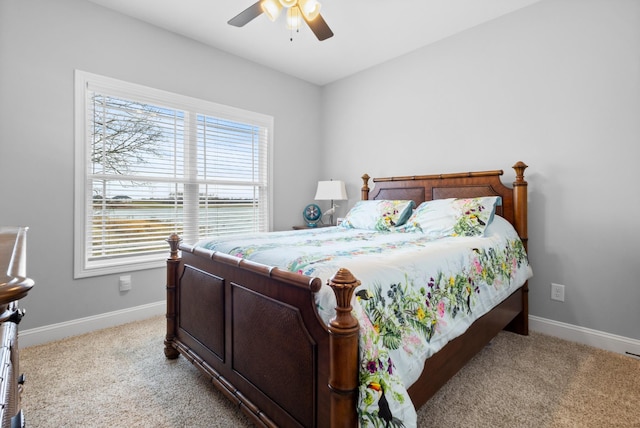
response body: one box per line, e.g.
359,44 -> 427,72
0,227 -> 33,428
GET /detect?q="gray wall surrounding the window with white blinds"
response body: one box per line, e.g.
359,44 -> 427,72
0,0 -> 321,329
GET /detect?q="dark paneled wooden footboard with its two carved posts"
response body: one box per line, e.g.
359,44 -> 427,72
165,235 -> 359,427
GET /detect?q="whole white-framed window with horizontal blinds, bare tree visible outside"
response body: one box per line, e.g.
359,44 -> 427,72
74,71 -> 273,278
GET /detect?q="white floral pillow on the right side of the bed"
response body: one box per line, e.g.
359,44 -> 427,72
399,196 -> 502,238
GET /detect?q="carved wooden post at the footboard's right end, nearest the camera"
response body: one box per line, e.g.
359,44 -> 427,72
327,269 -> 360,428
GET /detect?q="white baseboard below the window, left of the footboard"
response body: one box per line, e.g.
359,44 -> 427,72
19,301 -> 167,348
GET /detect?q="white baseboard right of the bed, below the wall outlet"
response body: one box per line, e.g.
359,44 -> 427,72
529,315 -> 640,358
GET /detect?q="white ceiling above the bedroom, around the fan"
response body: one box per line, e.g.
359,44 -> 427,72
89,0 -> 540,85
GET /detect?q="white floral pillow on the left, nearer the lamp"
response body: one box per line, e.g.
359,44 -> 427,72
340,200 -> 416,231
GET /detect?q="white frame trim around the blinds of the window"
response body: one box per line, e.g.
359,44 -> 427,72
74,70 -> 274,278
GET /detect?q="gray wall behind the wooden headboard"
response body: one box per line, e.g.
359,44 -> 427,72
322,0 -> 640,339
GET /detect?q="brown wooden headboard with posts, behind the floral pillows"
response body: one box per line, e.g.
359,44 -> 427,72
361,162 -> 528,248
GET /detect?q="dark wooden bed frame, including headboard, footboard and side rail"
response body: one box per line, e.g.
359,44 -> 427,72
164,162 -> 528,427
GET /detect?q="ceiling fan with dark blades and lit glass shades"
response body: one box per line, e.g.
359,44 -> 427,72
228,0 -> 333,41
